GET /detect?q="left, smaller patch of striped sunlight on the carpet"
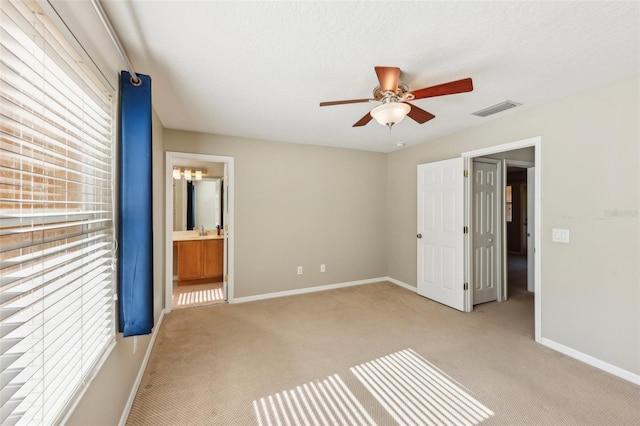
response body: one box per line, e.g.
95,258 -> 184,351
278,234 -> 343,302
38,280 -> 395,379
253,374 -> 376,426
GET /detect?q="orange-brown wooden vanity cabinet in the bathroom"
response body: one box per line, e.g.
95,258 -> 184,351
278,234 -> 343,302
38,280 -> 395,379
177,239 -> 224,285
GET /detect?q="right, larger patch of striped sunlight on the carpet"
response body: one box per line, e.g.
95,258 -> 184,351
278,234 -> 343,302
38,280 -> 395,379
351,349 -> 494,425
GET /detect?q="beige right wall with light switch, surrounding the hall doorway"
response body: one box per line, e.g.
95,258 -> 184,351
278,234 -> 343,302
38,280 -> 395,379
387,77 -> 640,374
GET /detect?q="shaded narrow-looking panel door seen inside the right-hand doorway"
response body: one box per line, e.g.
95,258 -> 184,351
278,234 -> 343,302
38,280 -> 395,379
471,160 -> 500,305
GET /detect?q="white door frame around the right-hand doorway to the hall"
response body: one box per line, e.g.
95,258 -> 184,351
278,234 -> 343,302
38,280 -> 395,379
462,136 -> 542,343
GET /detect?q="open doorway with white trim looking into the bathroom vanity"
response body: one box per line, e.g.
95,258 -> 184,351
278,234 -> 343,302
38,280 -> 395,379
164,152 -> 234,312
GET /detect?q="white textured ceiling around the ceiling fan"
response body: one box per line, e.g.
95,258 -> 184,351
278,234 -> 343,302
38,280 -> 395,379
89,0 -> 640,152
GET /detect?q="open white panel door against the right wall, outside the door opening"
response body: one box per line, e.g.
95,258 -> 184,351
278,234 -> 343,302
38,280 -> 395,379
417,158 -> 465,311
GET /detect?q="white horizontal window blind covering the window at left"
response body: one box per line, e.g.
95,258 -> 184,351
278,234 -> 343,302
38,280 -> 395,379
0,0 -> 115,425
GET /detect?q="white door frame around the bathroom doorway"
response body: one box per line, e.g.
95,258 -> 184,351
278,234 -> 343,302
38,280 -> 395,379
164,151 -> 235,313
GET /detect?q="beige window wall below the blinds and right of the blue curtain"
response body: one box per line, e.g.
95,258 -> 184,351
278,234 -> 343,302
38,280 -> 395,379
66,111 -> 164,425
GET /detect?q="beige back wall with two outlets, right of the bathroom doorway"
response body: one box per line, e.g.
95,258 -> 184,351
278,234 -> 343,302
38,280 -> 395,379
164,130 -> 387,297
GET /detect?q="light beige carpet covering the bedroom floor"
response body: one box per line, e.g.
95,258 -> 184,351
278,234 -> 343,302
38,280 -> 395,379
127,282 -> 640,425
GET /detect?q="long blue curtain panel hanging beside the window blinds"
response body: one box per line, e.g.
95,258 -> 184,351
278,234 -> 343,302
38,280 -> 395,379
118,71 -> 153,337
